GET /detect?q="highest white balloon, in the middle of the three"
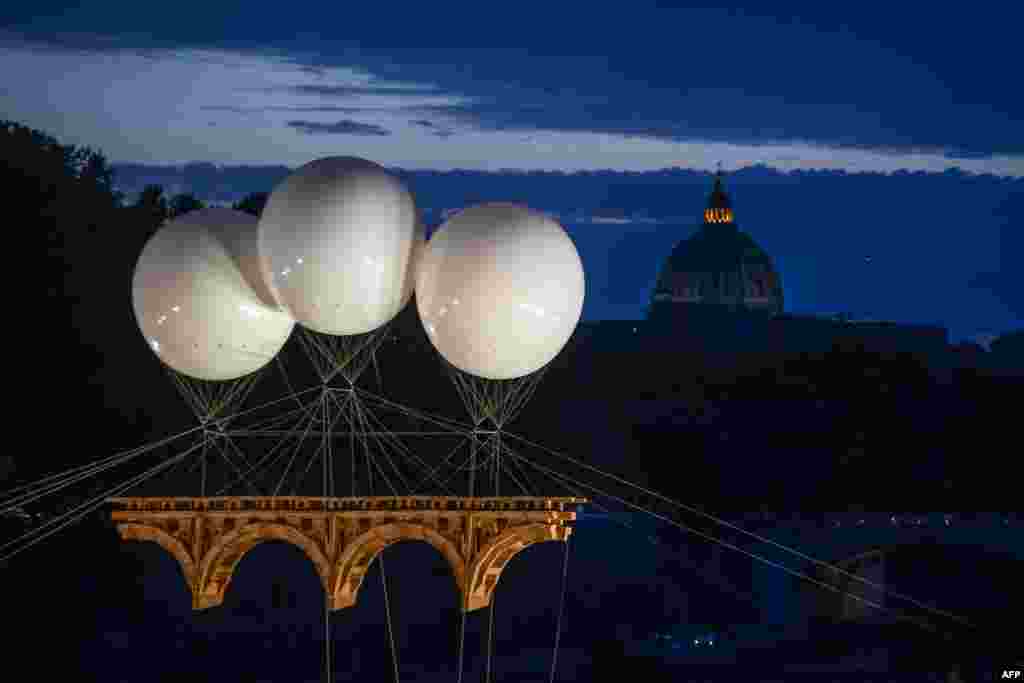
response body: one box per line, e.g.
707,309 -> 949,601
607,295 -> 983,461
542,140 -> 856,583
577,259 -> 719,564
259,157 -> 426,335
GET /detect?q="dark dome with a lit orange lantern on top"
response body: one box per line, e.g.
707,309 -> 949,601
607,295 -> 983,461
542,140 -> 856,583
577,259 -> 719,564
651,171 -> 783,317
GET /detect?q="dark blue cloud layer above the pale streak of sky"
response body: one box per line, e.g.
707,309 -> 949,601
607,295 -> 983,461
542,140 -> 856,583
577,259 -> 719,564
2,5 -> 1024,159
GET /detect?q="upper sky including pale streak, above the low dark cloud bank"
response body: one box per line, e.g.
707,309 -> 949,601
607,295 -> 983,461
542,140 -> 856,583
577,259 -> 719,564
0,0 -> 1024,175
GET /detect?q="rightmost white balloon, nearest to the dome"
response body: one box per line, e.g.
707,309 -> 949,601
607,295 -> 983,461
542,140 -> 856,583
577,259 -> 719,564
416,203 -> 584,380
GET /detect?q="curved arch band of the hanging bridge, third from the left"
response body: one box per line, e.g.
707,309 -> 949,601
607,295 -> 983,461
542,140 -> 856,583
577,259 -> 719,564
330,522 -> 466,609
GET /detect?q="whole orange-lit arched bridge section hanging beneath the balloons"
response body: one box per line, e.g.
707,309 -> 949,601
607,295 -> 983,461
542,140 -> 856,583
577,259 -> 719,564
109,497 -> 587,611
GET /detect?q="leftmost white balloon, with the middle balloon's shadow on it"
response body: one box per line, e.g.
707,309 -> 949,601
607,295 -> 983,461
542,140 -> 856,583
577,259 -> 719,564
132,209 -> 295,380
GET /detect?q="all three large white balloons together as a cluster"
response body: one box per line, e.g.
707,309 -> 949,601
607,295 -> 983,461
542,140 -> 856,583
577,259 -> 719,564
132,157 -> 584,381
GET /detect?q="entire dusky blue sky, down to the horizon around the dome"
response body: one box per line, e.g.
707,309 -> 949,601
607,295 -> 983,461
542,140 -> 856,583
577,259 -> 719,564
0,0 -> 1024,339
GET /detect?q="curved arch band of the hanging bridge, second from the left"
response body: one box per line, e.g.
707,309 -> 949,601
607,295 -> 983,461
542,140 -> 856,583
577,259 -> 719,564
193,521 -> 331,609
